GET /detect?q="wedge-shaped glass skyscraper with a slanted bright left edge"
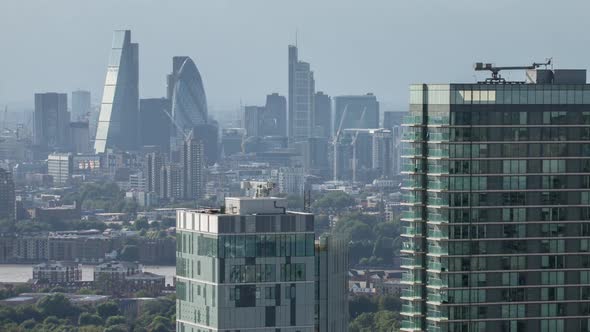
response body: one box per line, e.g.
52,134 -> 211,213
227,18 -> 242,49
94,30 -> 139,153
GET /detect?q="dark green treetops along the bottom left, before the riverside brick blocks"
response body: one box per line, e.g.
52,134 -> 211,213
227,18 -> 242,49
0,293 -> 176,332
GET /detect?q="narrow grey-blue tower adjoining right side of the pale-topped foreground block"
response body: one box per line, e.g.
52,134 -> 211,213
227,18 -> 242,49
315,234 -> 349,332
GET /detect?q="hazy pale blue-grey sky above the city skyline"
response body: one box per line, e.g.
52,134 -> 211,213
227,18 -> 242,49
0,0 -> 590,115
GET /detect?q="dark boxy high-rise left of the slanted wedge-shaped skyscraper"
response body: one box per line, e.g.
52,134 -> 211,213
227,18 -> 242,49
33,92 -> 70,150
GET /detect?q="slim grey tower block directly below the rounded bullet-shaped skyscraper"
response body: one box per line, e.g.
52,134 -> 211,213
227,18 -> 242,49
180,139 -> 205,200
